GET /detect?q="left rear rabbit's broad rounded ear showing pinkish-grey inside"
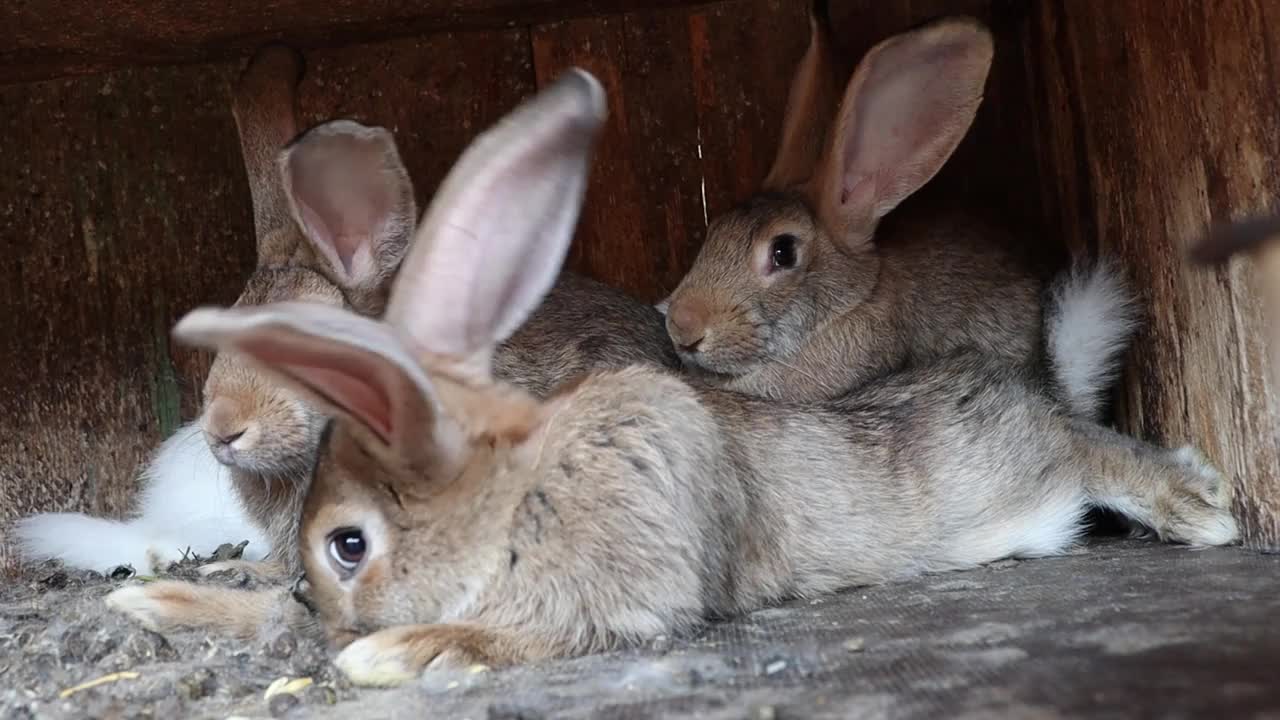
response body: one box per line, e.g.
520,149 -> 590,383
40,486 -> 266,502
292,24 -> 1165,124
279,120 -> 417,298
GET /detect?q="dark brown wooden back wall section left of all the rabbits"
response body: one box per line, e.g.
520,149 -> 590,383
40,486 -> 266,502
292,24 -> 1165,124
0,67 -> 253,566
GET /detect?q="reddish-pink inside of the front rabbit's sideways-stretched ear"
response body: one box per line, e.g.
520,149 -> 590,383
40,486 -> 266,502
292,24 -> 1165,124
243,342 -> 392,443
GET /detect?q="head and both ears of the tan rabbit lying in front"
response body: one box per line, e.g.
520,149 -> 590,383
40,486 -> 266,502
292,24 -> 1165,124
174,70 -> 605,644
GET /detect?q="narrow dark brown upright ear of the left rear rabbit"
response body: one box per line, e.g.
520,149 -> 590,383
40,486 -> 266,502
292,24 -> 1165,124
232,44 -> 302,265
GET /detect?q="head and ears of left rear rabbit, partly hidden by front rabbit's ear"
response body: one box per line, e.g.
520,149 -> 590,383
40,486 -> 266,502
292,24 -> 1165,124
198,46 -> 416,477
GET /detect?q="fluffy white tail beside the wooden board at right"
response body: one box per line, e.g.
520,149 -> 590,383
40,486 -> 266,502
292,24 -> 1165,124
1044,261 -> 1138,420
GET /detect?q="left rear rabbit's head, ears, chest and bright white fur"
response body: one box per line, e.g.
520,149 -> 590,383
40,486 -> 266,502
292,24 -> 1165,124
15,45 -> 417,577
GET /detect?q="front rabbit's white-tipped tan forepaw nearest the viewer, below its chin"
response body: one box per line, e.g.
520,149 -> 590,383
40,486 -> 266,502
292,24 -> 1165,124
334,625 -> 513,687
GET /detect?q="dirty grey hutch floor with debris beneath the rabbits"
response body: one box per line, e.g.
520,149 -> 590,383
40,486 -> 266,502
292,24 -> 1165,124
0,541 -> 1280,720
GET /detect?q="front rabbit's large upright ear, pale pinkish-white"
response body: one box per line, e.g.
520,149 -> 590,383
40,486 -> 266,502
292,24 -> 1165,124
387,69 -> 605,375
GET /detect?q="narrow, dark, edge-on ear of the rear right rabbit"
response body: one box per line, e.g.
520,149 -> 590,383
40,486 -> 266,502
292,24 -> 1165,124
764,0 -> 840,190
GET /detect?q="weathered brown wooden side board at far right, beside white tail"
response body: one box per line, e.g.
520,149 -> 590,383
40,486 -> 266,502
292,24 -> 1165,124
1030,0 -> 1280,548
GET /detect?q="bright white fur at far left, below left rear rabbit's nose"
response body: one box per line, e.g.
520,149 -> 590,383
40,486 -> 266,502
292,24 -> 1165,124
14,425 -> 270,574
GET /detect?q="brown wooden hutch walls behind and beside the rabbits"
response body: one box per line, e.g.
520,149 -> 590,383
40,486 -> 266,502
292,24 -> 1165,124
0,0 -> 1280,566
